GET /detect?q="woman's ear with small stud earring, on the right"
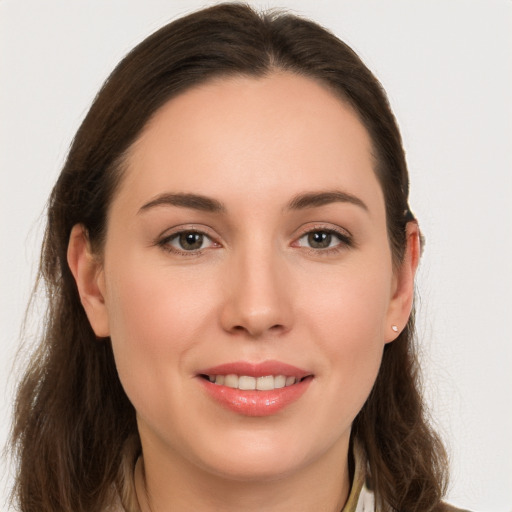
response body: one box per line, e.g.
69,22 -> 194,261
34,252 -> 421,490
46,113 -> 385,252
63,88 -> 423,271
384,221 -> 421,343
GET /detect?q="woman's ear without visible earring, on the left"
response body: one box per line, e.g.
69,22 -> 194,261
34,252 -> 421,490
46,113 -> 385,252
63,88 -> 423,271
67,224 -> 110,338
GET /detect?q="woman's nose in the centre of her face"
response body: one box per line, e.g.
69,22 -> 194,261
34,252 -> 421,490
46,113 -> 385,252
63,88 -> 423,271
221,245 -> 293,339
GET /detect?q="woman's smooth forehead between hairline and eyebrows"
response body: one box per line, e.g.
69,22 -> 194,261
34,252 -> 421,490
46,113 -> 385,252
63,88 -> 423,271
115,72 -> 380,214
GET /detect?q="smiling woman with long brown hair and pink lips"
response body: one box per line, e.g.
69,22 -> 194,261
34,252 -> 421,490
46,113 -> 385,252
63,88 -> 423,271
13,5 -> 462,512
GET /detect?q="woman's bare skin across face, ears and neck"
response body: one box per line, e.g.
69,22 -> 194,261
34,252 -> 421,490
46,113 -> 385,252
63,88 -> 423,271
68,73 -> 419,512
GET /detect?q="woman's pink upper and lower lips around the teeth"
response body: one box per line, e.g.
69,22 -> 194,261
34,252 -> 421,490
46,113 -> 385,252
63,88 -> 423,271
199,361 -> 312,416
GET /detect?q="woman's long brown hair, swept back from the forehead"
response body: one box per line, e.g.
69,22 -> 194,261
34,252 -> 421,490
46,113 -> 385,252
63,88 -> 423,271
12,4 -> 446,512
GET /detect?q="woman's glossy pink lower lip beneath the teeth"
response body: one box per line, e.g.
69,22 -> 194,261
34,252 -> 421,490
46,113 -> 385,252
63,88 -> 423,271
199,377 -> 313,416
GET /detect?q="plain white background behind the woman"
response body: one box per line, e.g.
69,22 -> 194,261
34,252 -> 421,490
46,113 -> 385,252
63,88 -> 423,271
0,0 -> 512,512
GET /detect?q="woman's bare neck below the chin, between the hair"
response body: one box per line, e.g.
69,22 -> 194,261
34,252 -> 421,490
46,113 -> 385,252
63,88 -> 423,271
135,440 -> 350,512
